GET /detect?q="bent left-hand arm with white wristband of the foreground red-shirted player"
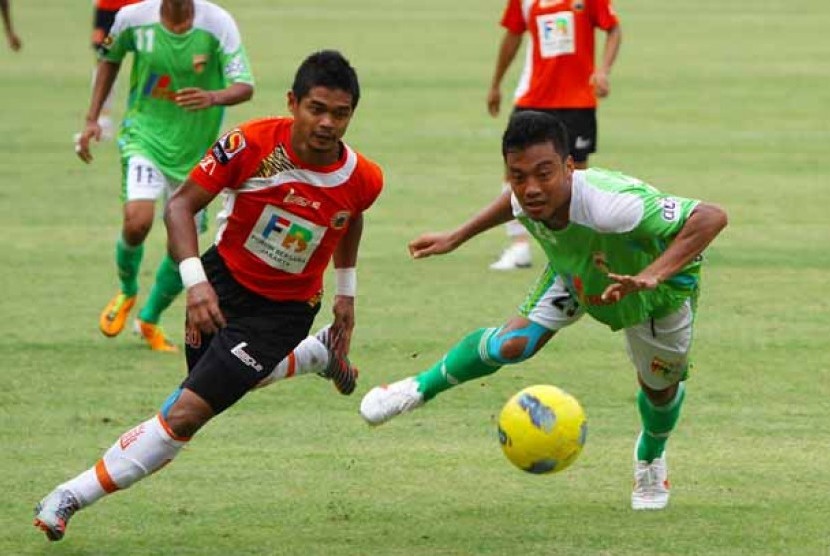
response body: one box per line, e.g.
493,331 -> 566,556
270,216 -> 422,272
164,179 -> 225,334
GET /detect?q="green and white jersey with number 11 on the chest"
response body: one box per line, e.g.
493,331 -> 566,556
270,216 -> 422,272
101,0 -> 253,180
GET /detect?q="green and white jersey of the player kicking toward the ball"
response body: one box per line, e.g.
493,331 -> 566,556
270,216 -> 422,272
511,168 -> 701,330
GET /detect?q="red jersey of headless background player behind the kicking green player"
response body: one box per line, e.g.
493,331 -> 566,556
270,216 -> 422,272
501,0 -> 618,109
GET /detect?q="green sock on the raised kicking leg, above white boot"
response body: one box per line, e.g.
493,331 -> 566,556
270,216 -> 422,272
415,328 -> 501,400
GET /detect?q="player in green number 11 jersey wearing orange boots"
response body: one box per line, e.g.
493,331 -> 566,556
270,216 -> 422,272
75,0 -> 254,351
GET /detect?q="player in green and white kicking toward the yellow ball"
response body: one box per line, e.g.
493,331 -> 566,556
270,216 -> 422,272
360,111 -> 727,510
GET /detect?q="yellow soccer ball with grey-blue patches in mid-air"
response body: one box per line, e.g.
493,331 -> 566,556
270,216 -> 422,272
499,384 -> 588,474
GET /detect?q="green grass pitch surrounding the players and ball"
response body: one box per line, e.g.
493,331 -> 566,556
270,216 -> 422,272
0,0 -> 830,556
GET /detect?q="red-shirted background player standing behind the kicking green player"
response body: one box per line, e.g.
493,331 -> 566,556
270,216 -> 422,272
487,0 -> 622,270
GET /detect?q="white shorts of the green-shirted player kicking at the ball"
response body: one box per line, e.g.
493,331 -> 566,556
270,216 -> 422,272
519,267 -> 694,390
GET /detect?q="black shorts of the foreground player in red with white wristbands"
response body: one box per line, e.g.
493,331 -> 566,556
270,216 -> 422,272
182,247 -> 320,414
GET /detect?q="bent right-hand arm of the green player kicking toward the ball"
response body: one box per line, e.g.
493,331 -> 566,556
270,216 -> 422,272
602,203 -> 728,303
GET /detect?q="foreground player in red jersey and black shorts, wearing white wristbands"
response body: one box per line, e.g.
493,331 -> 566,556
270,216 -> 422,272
35,51 -> 383,540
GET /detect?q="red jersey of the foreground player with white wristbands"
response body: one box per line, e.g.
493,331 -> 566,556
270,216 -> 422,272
190,118 -> 383,301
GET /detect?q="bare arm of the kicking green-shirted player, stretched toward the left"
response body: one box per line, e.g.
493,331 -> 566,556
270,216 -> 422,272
409,191 -> 513,259
